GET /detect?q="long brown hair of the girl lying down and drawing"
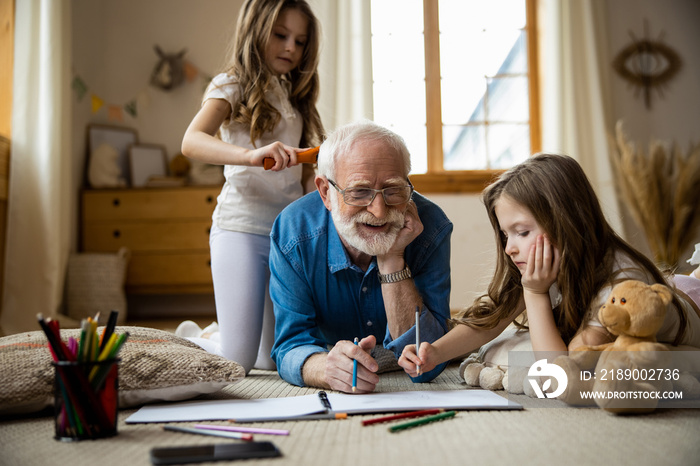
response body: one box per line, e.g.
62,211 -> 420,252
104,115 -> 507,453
456,154 -> 686,345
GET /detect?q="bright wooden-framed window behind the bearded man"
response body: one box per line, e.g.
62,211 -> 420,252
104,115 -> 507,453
371,0 -> 540,192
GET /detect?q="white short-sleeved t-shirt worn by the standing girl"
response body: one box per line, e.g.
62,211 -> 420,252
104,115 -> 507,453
205,73 -> 304,235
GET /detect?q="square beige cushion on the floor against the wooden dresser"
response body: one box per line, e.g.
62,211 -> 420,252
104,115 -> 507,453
66,248 -> 130,325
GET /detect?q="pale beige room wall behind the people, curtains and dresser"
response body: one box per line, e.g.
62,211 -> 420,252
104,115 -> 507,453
72,0 -> 700,316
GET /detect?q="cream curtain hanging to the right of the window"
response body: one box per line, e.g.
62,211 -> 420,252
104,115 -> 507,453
538,0 -> 624,236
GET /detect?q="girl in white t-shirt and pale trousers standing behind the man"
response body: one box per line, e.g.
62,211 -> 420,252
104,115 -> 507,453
176,0 -> 324,372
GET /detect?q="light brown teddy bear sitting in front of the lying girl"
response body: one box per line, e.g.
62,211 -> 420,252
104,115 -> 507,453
554,280 -> 680,413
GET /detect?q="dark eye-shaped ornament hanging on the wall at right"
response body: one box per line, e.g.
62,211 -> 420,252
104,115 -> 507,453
613,20 -> 682,110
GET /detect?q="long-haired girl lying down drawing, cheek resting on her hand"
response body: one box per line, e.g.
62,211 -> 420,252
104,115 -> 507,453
399,154 -> 700,376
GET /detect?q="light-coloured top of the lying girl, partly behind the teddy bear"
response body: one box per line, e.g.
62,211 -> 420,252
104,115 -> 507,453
549,251 -> 700,347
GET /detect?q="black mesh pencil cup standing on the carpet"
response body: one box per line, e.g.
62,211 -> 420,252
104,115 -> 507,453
53,359 -> 121,441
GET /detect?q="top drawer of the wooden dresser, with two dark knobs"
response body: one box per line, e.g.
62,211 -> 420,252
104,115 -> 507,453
83,187 -> 220,223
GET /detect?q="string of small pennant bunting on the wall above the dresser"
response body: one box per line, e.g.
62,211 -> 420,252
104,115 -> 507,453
71,51 -> 212,122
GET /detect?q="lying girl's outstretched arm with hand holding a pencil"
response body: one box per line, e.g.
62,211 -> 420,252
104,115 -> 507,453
399,312 -> 520,377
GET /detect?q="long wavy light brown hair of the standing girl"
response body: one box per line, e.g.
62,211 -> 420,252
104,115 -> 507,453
224,0 -> 324,147
